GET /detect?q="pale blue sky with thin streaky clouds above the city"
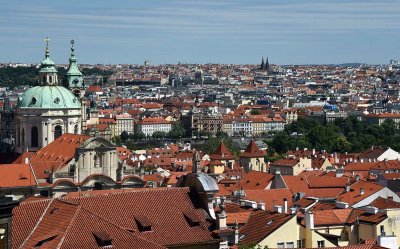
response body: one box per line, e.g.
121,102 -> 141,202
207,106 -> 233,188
0,0 -> 400,65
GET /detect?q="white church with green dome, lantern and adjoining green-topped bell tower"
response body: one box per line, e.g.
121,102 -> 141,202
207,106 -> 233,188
15,38 -> 83,153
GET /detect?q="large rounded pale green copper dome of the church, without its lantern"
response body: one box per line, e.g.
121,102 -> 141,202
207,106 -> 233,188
18,86 -> 81,109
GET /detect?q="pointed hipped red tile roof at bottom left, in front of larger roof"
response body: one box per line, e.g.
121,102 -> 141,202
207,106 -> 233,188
17,199 -> 165,249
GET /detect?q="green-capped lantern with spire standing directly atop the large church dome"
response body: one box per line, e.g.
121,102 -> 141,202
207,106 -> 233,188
39,37 -> 58,86
